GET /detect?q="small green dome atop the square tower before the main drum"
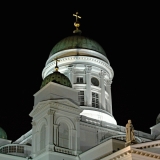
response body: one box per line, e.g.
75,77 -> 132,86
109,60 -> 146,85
41,71 -> 72,88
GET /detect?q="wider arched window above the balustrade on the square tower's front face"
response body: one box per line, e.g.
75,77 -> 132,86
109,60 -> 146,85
59,122 -> 69,148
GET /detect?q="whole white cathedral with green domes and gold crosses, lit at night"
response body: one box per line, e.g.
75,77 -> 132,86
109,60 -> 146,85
0,12 -> 160,160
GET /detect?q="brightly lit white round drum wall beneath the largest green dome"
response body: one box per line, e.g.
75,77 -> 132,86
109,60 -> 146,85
42,53 -> 117,124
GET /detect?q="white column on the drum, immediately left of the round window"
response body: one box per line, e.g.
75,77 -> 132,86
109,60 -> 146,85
86,66 -> 92,107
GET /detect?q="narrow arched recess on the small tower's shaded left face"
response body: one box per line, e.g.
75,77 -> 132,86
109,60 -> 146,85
40,125 -> 46,150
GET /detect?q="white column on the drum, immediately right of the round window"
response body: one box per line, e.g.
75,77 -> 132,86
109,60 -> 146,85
99,70 -> 106,110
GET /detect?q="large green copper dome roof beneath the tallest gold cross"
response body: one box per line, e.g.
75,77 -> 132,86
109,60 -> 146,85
49,35 -> 106,57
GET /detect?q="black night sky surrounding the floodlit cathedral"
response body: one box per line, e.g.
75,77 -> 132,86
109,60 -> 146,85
0,1 -> 160,141
